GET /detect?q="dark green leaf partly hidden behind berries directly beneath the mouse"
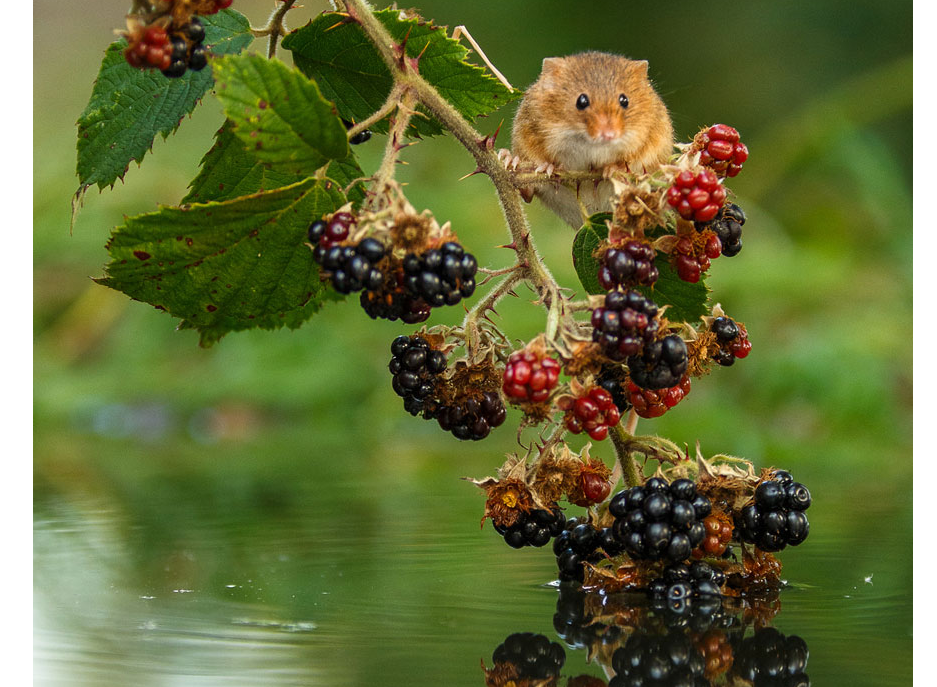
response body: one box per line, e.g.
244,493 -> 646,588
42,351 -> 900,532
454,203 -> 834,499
573,212 -> 710,323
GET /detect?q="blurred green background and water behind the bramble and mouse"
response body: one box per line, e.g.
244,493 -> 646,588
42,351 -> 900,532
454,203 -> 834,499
33,0 -> 912,685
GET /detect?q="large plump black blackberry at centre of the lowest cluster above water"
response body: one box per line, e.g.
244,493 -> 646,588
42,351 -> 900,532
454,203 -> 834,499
608,477 -> 712,563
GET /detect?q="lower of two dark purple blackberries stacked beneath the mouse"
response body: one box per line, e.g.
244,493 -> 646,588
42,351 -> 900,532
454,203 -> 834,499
592,291 -> 660,360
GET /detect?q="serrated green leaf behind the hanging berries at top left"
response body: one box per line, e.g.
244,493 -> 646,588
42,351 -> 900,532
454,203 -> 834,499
78,10 -> 253,195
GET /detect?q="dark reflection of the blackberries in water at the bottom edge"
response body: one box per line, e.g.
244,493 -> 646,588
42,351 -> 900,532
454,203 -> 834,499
485,585 -> 810,687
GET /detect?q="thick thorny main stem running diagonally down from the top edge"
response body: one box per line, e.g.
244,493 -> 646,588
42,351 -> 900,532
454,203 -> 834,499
345,0 -> 562,333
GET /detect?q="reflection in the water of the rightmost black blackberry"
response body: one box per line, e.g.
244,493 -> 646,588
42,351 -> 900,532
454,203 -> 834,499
732,627 -> 810,687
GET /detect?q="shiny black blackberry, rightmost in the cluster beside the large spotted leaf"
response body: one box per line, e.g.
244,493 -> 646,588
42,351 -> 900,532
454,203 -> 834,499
403,241 -> 478,307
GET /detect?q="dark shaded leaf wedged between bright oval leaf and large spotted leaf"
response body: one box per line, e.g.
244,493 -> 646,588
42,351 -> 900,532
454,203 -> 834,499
182,120 -> 302,203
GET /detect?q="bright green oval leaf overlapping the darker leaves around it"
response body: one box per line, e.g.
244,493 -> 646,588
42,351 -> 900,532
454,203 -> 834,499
212,55 -> 350,176
